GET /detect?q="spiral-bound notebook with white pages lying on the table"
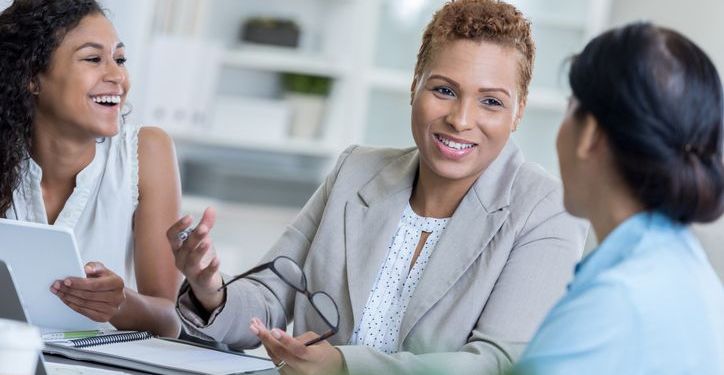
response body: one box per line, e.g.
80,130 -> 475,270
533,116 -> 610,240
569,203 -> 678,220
43,332 -> 274,375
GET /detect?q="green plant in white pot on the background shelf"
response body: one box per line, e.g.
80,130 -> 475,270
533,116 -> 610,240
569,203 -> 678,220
282,73 -> 332,139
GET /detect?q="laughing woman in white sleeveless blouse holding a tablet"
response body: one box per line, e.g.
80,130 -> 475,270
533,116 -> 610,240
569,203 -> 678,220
0,0 -> 180,336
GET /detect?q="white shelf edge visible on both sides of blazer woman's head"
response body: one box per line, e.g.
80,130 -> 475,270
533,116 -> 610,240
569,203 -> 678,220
368,68 -> 567,111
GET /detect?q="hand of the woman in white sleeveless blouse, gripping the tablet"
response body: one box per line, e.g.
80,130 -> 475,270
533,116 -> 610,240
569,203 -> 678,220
50,262 -> 126,322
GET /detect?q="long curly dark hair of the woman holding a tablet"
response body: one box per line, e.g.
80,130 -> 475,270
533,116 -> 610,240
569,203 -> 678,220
0,0 -> 104,217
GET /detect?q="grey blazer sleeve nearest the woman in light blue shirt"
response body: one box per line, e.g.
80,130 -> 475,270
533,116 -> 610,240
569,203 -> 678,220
339,189 -> 588,375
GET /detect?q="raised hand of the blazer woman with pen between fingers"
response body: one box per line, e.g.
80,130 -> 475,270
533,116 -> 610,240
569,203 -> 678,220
166,207 -> 224,311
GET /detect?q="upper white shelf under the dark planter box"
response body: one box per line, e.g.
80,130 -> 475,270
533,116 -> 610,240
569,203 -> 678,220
223,44 -> 346,77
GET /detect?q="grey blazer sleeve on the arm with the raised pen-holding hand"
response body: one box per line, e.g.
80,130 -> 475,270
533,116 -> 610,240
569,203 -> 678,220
176,146 -> 356,349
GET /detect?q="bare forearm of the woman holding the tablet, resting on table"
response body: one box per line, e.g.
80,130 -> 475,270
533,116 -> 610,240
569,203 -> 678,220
111,288 -> 181,337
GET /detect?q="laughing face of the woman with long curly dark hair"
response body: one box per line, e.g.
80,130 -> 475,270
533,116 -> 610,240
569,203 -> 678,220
31,14 -> 130,137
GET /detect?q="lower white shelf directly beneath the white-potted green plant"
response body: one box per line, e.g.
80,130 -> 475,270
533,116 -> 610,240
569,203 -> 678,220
169,130 -> 337,158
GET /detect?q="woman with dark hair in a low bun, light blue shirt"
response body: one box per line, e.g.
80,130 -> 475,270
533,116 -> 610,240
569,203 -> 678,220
517,23 -> 724,375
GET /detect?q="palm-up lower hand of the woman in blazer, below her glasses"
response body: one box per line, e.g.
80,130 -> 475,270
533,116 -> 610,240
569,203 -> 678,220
249,318 -> 344,375
